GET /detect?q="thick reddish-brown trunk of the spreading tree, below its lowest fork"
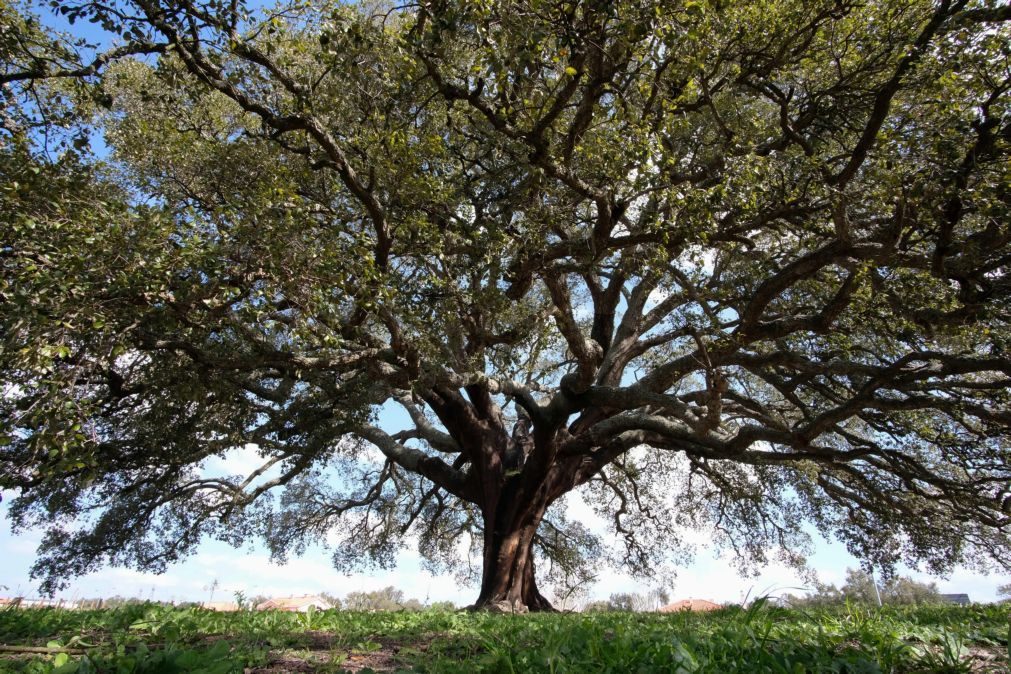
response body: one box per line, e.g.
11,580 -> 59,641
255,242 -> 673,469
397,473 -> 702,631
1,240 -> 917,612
472,495 -> 554,613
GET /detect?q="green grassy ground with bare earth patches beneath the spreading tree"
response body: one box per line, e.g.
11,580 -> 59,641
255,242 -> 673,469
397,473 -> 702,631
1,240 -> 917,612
0,603 -> 1011,674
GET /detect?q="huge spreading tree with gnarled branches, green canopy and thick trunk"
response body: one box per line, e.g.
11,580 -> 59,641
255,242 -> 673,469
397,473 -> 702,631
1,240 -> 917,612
0,0 -> 1011,609
